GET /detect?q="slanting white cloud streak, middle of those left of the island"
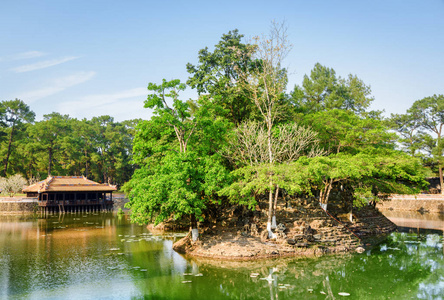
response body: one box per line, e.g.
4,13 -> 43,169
18,71 -> 96,103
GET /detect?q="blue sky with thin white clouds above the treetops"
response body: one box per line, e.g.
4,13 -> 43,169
0,0 -> 444,121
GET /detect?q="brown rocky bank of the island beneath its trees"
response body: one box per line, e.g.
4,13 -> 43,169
173,205 -> 397,260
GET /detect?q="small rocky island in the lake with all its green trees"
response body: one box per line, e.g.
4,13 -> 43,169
123,27 -> 444,259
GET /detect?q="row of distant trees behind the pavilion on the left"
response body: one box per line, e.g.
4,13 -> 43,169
0,99 -> 138,186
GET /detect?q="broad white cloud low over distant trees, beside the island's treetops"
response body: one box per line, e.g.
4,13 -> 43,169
58,88 -> 151,121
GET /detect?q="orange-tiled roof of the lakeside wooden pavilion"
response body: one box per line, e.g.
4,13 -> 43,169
23,176 -> 117,193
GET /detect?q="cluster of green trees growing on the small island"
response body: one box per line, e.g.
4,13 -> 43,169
124,24 -> 434,236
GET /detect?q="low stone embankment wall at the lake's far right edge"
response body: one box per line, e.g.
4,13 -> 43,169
376,194 -> 444,214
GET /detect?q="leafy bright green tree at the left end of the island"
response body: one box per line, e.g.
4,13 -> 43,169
124,80 -> 229,239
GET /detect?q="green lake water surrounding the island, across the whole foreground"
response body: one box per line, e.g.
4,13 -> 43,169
0,213 -> 444,300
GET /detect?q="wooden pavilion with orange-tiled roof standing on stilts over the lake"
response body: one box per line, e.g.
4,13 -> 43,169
23,176 -> 117,213
